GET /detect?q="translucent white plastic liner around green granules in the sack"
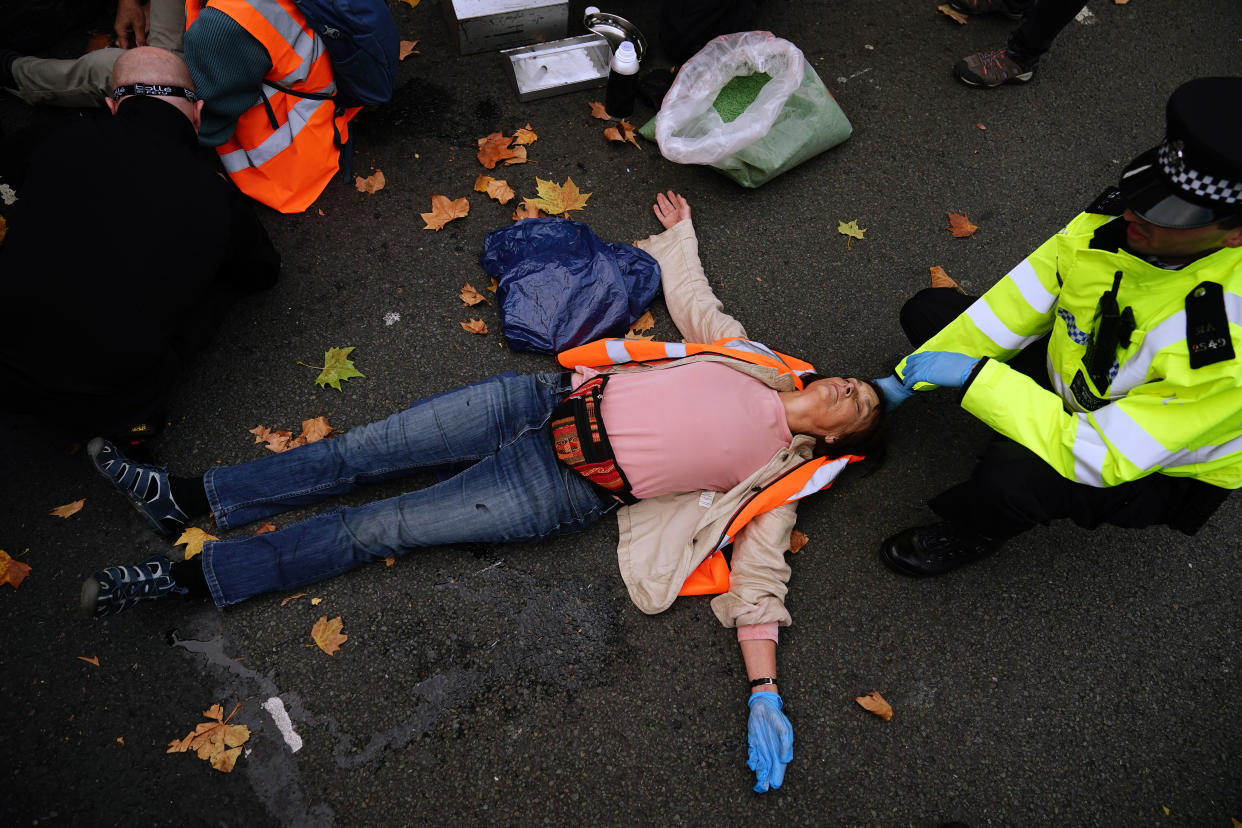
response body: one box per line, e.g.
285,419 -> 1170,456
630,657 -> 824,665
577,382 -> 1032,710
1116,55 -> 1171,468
656,31 -> 807,164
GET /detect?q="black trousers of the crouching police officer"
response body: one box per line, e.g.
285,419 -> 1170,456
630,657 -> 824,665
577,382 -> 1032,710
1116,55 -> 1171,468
902,288 -> 1230,541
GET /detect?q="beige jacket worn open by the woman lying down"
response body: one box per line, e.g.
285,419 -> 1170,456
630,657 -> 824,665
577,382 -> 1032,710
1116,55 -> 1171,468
578,220 -> 815,627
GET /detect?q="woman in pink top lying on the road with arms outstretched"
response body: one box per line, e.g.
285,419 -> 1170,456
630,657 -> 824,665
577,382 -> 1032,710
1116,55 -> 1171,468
82,192 -> 883,792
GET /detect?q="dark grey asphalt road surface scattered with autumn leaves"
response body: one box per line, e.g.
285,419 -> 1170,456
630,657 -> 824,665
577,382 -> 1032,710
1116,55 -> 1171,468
0,0 -> 1242,828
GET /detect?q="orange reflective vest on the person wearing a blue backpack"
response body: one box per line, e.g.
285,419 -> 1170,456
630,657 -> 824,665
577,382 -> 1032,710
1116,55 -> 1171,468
185,0 -> 359,212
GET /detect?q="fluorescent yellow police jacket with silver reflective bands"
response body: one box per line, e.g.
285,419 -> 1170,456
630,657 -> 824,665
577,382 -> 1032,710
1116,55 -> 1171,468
897,212 -> 1242,489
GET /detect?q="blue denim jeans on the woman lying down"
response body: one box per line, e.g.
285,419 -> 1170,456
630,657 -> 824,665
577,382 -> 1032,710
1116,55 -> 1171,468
202,374 -> 611,607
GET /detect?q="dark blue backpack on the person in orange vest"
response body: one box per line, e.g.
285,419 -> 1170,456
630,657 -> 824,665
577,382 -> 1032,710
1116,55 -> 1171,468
293,0 -> 401,108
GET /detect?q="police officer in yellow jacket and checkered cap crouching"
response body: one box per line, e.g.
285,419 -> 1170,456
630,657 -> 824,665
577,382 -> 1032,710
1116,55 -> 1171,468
879,77 -> 1242,577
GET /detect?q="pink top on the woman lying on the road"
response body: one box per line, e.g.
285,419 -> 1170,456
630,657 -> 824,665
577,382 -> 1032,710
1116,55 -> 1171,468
602,362 -> 794,498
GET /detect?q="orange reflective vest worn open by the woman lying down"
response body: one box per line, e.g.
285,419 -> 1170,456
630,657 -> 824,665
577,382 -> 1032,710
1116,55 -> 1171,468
556,338 -> 863,596
